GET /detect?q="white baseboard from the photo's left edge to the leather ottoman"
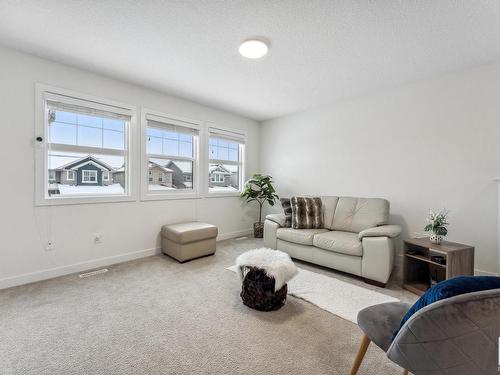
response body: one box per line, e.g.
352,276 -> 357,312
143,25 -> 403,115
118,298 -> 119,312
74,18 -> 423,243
0,248 -> 161,289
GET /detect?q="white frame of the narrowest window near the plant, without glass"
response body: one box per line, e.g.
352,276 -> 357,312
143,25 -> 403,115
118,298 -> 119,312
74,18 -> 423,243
204,123 -> 247,197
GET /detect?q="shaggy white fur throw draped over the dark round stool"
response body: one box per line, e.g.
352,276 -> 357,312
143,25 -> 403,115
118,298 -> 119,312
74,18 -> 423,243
236,247 -> 298,291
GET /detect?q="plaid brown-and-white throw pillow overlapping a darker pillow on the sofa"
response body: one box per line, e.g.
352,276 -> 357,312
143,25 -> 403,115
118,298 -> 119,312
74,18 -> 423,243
290,197 -> 323,229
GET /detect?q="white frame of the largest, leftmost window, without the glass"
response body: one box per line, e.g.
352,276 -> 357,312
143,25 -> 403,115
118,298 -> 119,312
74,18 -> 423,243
35,83 -> 137,206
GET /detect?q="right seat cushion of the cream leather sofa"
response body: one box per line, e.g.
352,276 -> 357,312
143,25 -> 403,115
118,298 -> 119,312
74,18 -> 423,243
313,231 -> 363,257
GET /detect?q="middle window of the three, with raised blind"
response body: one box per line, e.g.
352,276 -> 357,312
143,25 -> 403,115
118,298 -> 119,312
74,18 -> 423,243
143,110 -> 199,199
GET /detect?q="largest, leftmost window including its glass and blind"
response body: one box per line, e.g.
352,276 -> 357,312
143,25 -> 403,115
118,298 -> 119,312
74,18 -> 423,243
37,85 -> 135,204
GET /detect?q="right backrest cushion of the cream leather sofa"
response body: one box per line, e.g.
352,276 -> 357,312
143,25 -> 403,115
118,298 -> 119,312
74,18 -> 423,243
331,197 -> 389,233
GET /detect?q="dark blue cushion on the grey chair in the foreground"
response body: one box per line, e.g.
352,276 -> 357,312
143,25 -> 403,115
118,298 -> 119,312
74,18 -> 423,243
392,276 -> 500,339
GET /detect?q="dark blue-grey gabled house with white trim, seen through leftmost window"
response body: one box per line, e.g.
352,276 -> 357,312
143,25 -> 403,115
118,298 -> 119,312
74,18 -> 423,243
49,155 -> 114,194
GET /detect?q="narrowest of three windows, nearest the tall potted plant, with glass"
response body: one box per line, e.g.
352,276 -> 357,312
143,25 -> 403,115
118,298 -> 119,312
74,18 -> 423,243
208,127 -> 245,193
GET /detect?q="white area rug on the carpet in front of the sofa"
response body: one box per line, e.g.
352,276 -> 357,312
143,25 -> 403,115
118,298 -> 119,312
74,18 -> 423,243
227,266 -> 399,323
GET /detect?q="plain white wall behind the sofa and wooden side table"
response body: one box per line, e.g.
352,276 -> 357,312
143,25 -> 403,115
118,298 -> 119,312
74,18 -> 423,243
261,64 -> 500,272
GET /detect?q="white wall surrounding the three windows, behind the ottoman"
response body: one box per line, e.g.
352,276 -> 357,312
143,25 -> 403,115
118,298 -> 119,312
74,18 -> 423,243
0,48 -> 259,288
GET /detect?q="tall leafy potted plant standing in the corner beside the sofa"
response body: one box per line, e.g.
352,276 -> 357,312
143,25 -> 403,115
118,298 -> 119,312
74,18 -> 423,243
240,173 -> 279,238
